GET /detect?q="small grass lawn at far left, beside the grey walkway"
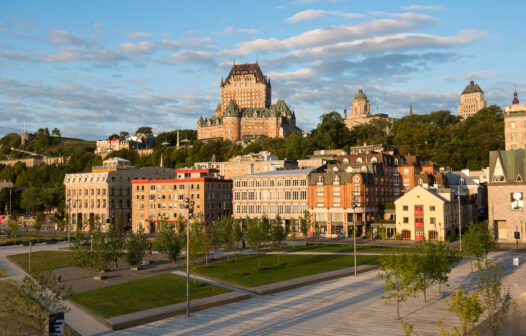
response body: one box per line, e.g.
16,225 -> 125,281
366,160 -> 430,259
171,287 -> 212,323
8,251 -> 76,272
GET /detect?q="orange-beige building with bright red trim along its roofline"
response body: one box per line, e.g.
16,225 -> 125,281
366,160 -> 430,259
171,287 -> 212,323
132,169 -> 232,234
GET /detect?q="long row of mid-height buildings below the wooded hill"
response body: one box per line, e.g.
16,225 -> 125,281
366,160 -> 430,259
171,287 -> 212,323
64,145 -> 485,239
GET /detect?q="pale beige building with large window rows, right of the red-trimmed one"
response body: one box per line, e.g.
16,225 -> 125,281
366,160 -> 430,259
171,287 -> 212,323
233,168 -> 313,225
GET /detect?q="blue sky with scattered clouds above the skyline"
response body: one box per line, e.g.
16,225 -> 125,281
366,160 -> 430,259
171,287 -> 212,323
0,0 -> 526,140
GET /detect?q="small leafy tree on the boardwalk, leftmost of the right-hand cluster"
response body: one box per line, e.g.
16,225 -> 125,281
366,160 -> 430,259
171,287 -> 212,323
378,253 -> 419,319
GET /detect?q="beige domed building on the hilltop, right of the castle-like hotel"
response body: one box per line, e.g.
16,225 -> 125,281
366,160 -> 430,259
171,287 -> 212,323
343,89 -> 395,134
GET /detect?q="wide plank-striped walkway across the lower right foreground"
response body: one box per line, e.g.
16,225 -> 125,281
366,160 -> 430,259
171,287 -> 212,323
113,252 -> 526,336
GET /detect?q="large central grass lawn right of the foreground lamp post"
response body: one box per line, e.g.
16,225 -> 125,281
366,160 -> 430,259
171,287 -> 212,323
196,255 -> 379,287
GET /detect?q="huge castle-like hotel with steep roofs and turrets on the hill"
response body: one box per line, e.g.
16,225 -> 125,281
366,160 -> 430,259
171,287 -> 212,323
197,63 -> 296,141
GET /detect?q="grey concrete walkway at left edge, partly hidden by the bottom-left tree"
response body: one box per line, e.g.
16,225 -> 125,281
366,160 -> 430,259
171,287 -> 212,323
0,243 -> 110,336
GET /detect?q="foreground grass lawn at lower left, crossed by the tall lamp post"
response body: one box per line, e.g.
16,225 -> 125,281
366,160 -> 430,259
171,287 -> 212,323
69,274 -> 229,318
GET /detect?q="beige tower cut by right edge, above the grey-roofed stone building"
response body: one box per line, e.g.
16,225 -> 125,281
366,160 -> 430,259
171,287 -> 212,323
504,91 -> 526,150
